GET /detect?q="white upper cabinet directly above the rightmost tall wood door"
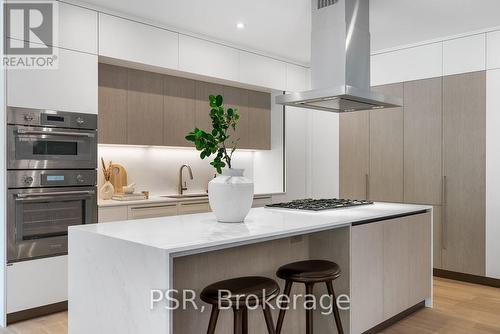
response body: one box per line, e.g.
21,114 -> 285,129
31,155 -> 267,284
443,34 -> 486,75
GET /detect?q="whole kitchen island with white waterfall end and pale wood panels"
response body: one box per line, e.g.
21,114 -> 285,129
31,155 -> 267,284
68,203 -> 432,334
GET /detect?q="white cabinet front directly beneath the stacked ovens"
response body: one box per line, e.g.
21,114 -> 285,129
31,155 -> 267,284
7,255 -> 68,313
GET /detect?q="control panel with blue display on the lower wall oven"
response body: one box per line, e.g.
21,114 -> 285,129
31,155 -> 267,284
7,170 -> 97,189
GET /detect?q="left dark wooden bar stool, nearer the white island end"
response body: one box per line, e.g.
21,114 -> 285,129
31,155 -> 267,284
200,276 -> 280,334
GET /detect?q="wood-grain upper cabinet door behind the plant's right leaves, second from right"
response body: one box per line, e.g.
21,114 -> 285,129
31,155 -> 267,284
223,86 -> 250,148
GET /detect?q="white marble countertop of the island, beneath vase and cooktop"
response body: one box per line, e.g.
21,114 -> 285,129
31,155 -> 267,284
69,203 -> 432,256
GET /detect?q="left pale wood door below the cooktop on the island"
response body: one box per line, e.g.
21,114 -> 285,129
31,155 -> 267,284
351,222 -> 385,333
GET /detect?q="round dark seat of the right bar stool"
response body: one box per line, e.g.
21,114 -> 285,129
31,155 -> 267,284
276,260 -> 340,283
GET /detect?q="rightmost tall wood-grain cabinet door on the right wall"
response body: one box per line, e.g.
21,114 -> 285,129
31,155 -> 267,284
443,72 -> 486,275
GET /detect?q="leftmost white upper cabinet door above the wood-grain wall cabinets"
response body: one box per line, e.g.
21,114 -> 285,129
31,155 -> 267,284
99,13 -> 179,69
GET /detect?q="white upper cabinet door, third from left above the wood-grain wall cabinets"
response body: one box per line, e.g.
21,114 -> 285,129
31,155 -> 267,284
239,51 -> 286,90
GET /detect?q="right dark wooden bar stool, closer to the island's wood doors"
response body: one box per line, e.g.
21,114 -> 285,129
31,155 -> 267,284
276,260 -> 344,334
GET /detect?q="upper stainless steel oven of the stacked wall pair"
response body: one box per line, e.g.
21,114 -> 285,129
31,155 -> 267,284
7,107 -> 97,169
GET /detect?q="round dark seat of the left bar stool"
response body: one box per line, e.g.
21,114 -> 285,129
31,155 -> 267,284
200,276 -> 280,307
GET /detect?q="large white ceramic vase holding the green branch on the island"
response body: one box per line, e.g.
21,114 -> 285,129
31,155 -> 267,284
208,168 -> 253,223
